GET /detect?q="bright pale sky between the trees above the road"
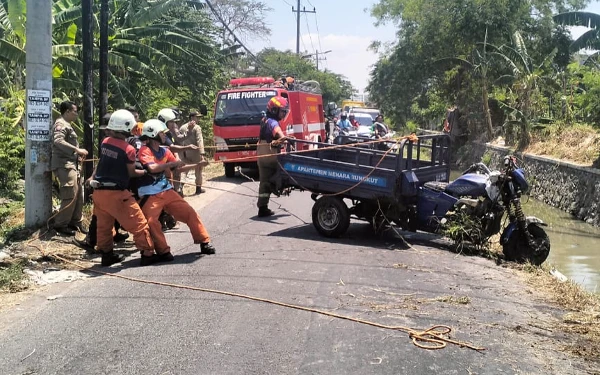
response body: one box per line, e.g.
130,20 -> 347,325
245,0 -> 600,93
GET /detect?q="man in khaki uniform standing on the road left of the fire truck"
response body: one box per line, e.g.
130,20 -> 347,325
175,112 -> 208,195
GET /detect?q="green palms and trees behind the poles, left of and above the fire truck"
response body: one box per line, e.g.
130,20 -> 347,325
0,0 -> 352,191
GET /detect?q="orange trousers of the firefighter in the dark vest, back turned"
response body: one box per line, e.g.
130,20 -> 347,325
92,190 -> 154,256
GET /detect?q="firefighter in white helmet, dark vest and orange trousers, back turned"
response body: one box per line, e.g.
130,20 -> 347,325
87,109 -> 159,266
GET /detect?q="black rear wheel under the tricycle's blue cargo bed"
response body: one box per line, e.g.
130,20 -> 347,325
312,197 -> 350,237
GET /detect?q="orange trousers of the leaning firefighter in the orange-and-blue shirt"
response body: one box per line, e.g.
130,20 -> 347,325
142,189 -> 210,254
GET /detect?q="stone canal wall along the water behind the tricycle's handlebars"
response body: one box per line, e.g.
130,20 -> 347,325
457,144 -> 600,227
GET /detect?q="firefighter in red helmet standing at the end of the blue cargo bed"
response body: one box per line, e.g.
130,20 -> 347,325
256,96 -> 289,217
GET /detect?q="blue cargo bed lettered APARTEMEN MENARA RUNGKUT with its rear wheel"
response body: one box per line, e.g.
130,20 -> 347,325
273,135 -> 450,237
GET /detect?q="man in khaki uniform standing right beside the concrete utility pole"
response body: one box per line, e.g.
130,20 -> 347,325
51,101 -> 88,236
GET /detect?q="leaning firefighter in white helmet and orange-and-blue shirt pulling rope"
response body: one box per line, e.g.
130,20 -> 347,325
138,120 -> 215,262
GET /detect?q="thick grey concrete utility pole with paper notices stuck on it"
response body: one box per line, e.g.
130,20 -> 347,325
25,1 -> 52,228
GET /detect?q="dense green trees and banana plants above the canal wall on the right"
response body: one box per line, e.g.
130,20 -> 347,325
368,0 -> 600,147
